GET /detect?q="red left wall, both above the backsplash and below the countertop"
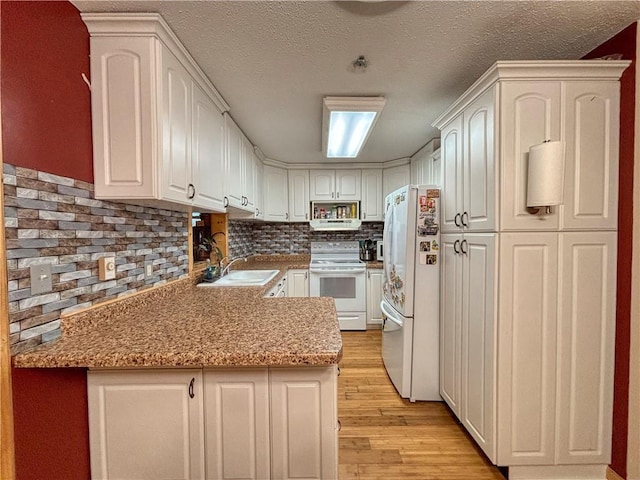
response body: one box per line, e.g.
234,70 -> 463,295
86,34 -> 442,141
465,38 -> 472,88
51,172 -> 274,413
0,0 -> 93,480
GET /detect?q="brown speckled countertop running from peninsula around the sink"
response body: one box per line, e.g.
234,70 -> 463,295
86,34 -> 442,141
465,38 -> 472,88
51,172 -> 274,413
13,255 -> 342,368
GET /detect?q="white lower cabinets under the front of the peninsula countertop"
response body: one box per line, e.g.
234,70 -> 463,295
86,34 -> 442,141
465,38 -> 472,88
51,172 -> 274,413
87,365 -> 338,480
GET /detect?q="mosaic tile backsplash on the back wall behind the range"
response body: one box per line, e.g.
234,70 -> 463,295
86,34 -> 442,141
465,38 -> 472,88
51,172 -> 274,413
235,221 -> 384,258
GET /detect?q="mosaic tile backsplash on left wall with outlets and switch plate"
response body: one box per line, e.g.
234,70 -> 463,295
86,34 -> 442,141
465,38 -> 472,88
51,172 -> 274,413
3,164 -> 189,353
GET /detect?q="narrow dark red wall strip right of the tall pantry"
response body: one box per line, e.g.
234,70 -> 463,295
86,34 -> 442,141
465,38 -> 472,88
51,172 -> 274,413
584,23 -> 637,478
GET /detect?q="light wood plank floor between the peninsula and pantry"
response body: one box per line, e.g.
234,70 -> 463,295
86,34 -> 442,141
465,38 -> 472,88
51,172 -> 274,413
338,330 -> 504,480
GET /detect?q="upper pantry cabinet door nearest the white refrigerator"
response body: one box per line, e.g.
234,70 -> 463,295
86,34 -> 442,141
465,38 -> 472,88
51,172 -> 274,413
440,115 -> 462,233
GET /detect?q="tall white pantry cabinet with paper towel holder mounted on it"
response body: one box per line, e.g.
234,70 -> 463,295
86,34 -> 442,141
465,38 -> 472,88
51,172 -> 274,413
434,60 -> 629,479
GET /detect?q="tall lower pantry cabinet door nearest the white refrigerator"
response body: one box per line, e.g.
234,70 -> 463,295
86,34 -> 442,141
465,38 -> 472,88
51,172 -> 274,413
440,234 -> 462,417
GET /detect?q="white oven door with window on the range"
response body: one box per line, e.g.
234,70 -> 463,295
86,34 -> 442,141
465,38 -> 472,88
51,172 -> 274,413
309,267 -> 367,312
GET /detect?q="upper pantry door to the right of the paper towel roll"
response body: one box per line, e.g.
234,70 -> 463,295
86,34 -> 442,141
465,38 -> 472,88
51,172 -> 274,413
561,81 -> 620,230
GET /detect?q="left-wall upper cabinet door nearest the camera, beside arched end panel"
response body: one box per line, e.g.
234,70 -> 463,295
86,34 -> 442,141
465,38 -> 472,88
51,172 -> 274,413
160,48 -> 193,204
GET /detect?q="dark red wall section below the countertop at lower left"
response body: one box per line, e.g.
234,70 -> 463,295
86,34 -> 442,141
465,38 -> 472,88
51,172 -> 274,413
12,368 -> 91,480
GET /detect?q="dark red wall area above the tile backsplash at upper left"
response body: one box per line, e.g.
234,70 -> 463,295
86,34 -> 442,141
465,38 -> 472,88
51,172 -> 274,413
0,0 -> 93,183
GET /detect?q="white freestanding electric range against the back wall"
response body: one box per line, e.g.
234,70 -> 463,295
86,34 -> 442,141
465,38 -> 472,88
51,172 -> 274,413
309,242 -> 367,330
